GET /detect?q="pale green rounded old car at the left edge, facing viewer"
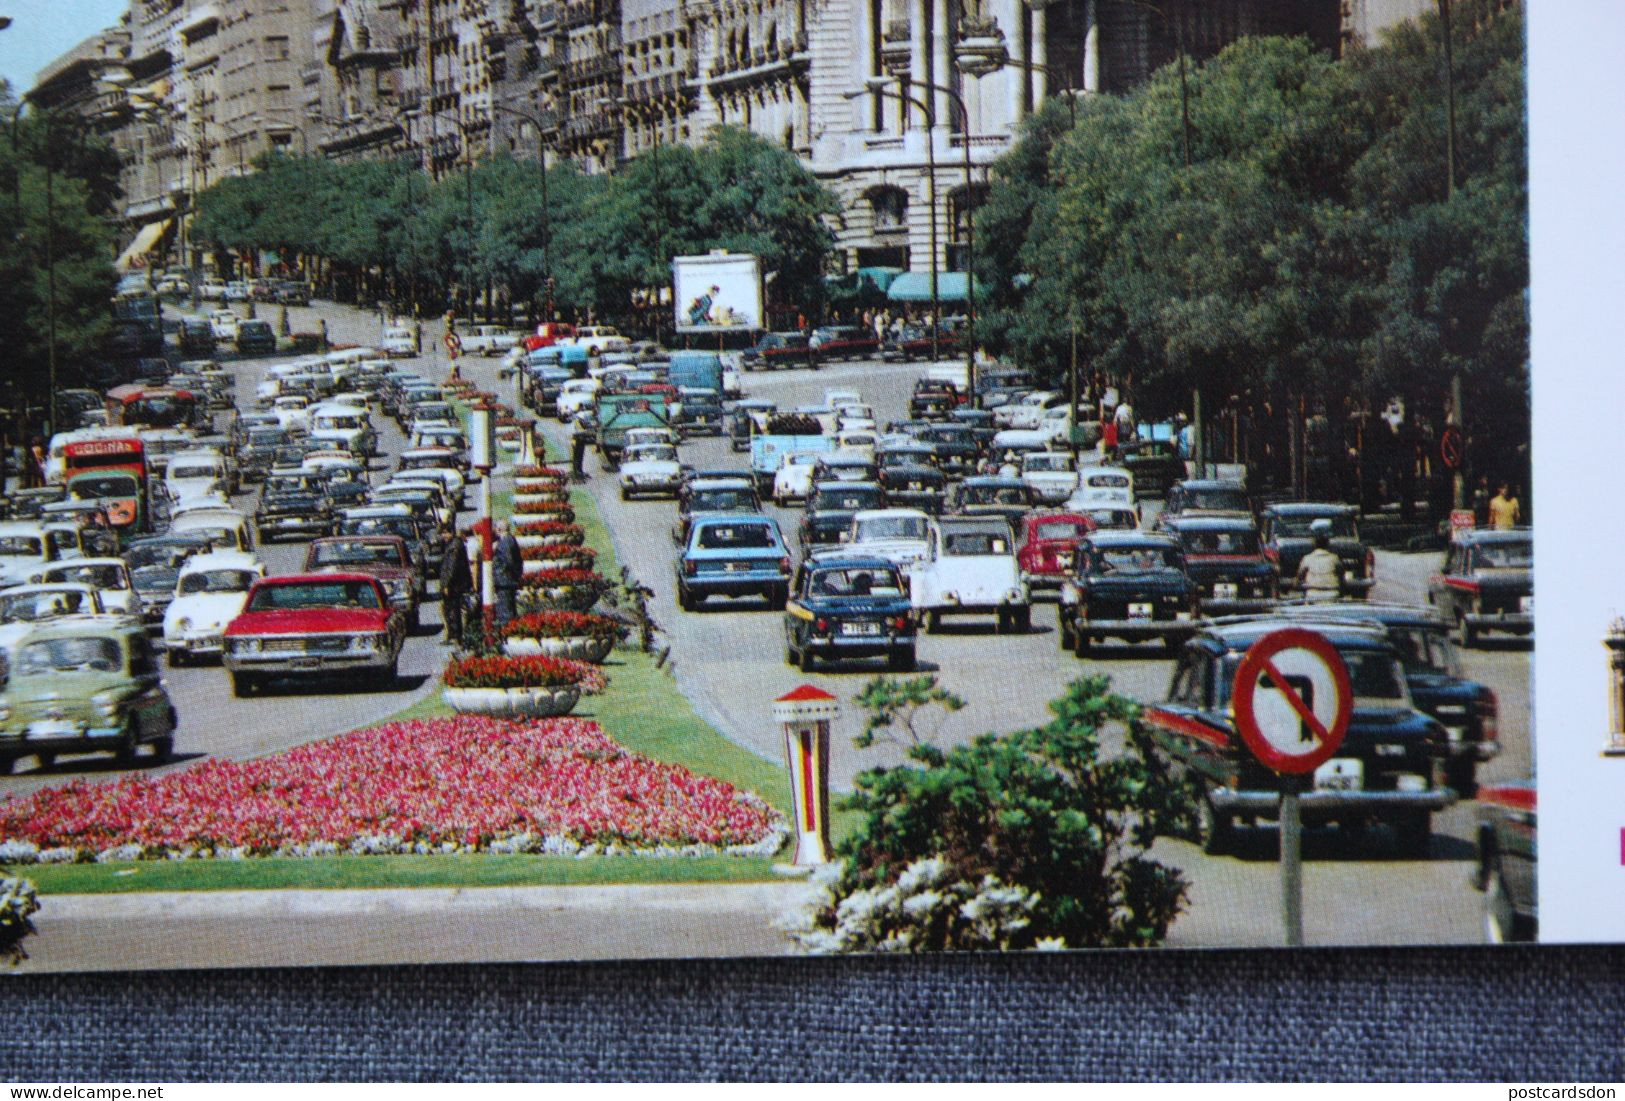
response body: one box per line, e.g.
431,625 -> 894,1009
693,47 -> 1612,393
0,615 -> 176,775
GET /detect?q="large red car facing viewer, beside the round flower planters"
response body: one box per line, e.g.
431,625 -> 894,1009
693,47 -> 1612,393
224,573 -> 406,697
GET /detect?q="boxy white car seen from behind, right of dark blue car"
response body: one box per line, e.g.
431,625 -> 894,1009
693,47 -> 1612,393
908,516 -> 1032,633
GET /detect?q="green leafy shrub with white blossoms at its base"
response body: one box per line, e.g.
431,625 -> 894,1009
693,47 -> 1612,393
795,677 -> 1193,952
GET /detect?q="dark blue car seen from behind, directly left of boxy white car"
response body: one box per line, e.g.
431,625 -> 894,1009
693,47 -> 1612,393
785,554 -> 915,672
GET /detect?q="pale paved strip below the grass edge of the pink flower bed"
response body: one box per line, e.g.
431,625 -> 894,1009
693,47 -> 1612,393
18,876 -> 811,973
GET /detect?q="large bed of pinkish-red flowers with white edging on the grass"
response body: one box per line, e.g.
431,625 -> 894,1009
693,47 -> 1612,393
0,716 -> 787,864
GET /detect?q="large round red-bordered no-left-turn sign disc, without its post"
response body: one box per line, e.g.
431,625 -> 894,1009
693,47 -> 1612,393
1232,627 -> 1354,773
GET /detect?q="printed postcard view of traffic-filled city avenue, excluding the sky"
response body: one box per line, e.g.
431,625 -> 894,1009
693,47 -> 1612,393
0,0 -> 1534,971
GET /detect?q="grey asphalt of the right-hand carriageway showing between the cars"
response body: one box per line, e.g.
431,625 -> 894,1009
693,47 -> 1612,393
526,347 -> 1532,945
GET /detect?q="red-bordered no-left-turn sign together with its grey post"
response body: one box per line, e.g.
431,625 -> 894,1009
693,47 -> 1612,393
1230,627 -> 1354,947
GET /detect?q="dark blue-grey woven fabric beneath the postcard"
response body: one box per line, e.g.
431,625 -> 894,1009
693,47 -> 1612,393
0,948 -> 1625,1082
